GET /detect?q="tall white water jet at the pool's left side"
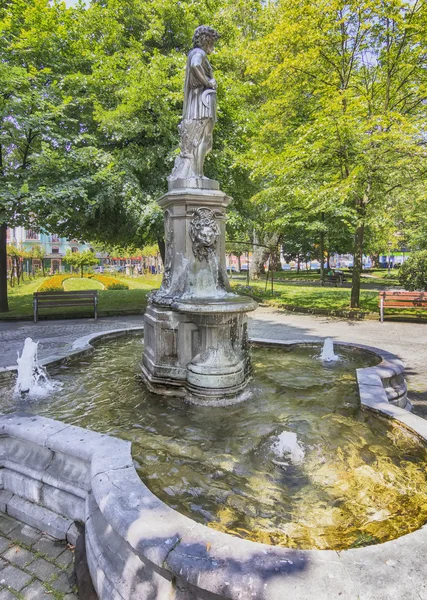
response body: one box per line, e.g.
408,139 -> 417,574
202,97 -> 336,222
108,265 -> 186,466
15,338 -> 62,397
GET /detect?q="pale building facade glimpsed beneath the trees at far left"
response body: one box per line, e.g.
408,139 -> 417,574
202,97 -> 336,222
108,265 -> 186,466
7,227 -> 90,273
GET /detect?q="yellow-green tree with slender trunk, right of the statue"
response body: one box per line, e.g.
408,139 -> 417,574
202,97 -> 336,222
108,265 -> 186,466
247,0 -> 427,308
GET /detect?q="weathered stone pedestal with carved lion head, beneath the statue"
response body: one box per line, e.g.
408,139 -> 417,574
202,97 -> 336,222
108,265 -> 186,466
142,180 -> 256,403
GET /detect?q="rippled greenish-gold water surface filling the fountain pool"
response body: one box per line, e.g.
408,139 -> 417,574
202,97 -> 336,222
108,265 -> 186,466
1,337 -> 427,549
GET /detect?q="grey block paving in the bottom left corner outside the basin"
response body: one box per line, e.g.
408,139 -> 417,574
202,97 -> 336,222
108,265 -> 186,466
0,515 -> 78,600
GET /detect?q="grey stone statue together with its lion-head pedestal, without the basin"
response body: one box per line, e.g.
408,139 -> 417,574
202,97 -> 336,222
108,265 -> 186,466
142,26 -> 256,403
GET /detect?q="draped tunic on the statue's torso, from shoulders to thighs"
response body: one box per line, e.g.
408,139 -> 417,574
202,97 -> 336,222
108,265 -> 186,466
182,48 -> 216,122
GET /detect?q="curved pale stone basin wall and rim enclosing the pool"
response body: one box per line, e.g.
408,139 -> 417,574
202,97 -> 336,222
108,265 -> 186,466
0,329 -> 427,600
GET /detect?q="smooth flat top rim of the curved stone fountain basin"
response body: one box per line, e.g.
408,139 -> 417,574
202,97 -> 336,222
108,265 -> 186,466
0,327 -> 427,600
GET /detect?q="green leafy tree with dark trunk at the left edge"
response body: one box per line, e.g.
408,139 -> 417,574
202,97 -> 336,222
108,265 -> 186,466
0,0 -> 149,312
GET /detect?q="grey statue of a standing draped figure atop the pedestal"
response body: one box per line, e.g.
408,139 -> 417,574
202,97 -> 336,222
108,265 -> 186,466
169,25 -> 219,182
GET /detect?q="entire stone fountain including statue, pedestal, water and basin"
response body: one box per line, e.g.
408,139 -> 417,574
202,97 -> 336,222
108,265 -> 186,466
0,27 -> 427,600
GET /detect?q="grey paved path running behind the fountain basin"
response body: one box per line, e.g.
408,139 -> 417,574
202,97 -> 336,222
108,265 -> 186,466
0,307 -> 427,414
